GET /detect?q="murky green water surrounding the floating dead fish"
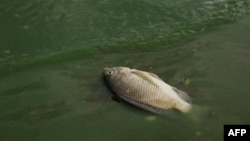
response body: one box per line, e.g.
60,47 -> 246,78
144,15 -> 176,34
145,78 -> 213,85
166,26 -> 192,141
0,0 -> 250,141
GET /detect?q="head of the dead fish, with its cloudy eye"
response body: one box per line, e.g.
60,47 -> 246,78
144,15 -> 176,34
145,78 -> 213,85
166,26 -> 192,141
102,67 -> 130,84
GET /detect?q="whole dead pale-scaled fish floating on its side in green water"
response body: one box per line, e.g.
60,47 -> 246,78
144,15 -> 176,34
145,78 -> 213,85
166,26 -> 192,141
102,67 -> 192,114
